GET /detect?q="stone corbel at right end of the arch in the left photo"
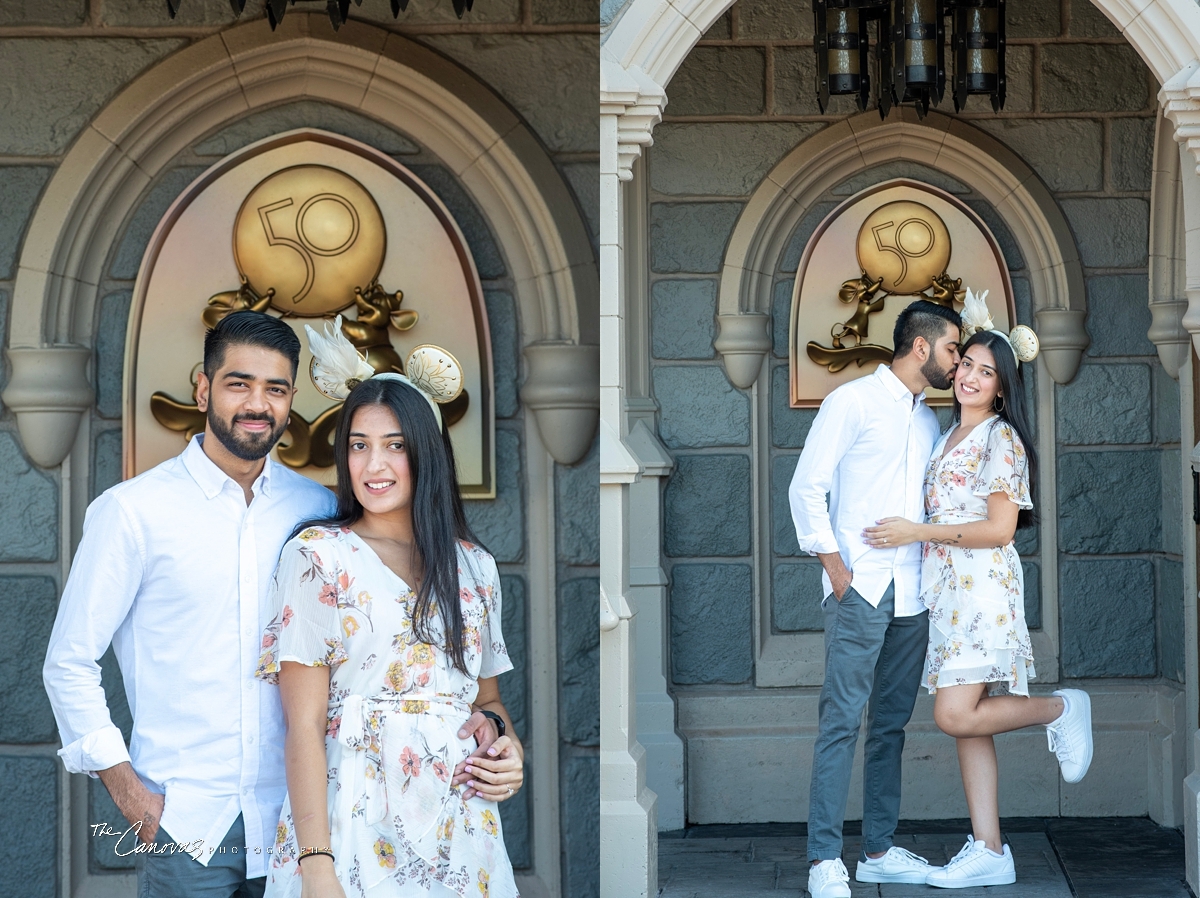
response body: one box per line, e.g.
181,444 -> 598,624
521,342 -> 600,465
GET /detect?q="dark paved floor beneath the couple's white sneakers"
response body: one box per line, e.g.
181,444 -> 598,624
659,818 -> 1195,898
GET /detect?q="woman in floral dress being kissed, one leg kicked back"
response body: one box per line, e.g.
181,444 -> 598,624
864,313 -> 1092,888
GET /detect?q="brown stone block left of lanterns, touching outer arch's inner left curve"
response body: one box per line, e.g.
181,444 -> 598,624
672,47 -> 767,117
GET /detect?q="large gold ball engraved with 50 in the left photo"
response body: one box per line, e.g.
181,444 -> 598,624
233,166 -> 388,318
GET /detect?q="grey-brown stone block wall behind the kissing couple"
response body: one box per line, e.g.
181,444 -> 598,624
652,0 -> 1183,688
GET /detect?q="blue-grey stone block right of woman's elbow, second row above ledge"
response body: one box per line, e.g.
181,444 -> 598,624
1058,449 -> 1162,554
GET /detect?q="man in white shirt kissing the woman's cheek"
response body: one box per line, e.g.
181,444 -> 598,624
788,300 -> 961,898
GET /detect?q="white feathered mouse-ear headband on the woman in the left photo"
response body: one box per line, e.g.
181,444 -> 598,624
304,316 -> 463,430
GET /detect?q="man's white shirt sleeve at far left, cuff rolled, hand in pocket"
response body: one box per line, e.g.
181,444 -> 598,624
42,493 -> 144,776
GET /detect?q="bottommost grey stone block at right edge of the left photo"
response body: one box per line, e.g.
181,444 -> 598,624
559,749 -> 600,898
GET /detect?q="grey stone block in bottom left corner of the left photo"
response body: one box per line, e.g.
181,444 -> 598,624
0,753 -> 59,898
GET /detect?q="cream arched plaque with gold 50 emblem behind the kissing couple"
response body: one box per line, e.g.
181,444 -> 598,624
788,179 -> 1016,408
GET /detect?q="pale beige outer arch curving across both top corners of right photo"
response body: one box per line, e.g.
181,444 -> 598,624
604,0 -> 1200,88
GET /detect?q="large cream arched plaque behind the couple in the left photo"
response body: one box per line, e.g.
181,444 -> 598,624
124,128 -> 496,498
